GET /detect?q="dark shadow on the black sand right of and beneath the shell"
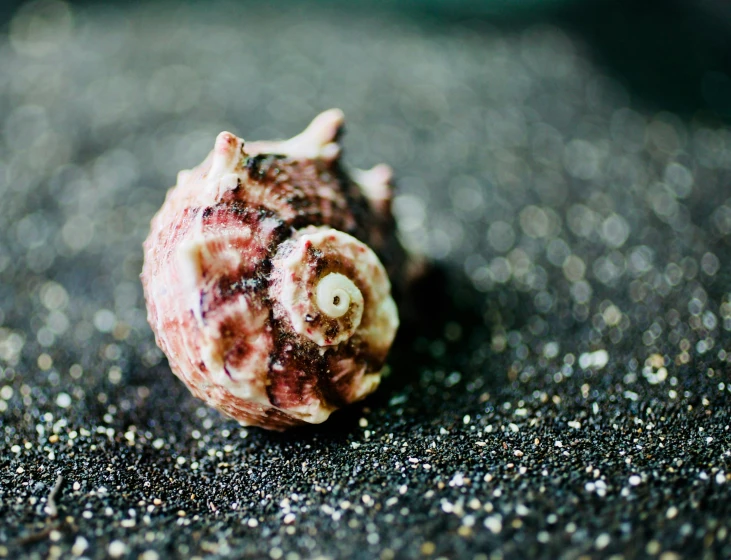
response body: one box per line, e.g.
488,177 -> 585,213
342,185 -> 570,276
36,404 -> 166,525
272,266 -> 524,443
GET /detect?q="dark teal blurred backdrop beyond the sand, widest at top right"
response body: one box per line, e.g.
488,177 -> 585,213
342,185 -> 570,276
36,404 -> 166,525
0,0 -> 731,120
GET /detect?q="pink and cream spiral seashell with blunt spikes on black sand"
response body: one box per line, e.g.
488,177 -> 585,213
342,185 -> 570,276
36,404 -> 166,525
141,109 -> 405,430
